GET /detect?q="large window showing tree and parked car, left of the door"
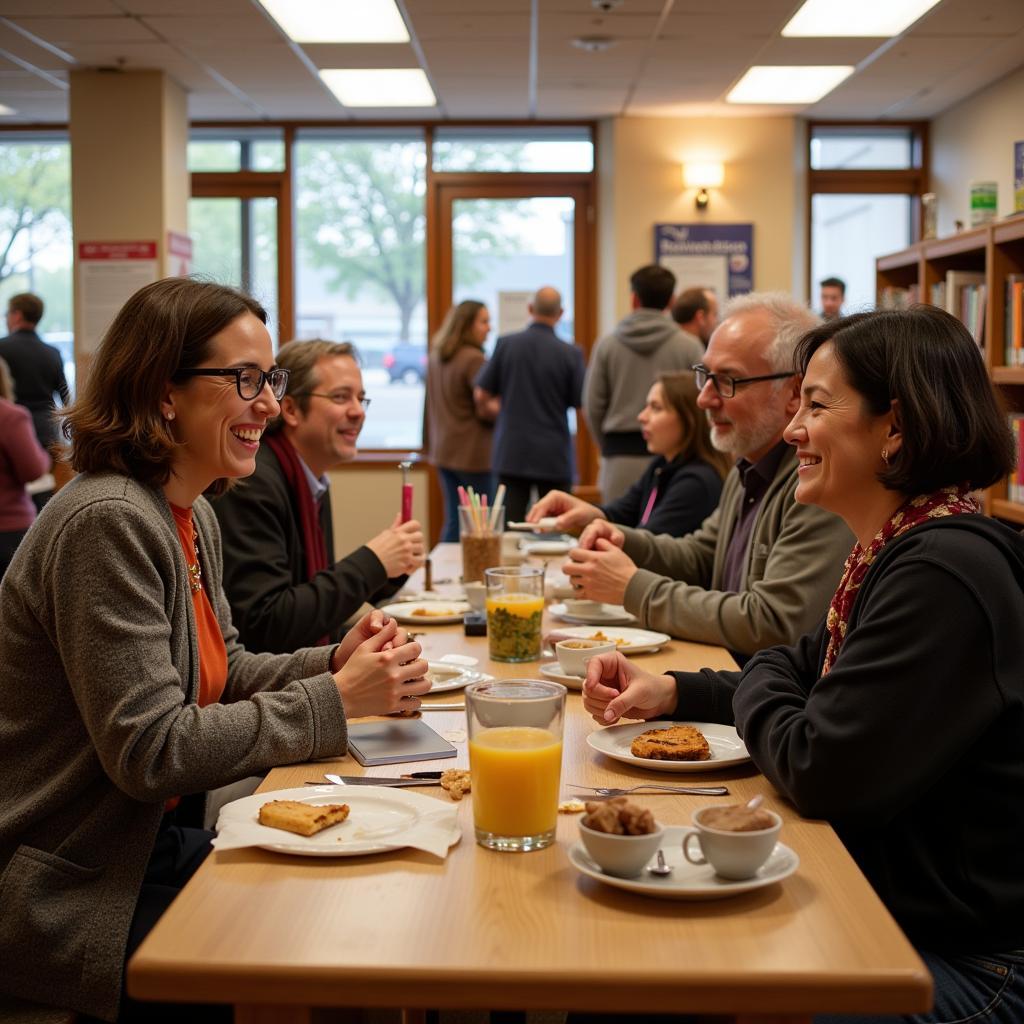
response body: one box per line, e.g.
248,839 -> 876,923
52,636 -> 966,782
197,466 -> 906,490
295,131 -> 427,449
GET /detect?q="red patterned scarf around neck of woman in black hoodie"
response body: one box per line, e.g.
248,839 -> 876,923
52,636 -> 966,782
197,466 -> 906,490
821,486 -> 981,676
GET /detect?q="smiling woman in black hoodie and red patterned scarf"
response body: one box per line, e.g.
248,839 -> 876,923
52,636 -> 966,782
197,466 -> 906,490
584,306 -> 1024,1024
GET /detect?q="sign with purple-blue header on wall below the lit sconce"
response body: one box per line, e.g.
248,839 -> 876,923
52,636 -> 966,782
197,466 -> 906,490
654,224 -> 754,299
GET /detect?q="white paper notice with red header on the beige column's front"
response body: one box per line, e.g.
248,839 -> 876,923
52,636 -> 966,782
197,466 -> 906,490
76,242 -> 159,354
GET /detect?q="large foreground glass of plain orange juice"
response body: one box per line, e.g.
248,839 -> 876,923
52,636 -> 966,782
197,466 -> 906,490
466,679 -> 565,853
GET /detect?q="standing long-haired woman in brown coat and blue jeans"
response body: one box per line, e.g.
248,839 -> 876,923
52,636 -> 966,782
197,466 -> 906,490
426,299 -> 498,542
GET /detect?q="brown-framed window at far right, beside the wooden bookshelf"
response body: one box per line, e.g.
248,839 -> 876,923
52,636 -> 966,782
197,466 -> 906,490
809,124 -> 928,312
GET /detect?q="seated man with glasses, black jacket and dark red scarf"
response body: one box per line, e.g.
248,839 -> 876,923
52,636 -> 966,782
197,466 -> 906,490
213,340 -> 424,652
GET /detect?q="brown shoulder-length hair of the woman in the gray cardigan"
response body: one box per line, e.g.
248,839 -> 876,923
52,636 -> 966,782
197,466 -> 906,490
63,278 -> 266,490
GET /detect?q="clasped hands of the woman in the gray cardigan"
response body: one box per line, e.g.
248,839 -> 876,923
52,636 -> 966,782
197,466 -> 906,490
334,612 -> 430,719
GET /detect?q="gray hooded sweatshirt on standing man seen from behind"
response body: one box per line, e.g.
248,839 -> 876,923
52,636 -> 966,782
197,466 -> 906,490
584,309 -> 703,456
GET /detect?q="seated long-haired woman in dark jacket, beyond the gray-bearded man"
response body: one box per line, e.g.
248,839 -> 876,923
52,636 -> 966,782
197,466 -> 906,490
526,372 -> 731,537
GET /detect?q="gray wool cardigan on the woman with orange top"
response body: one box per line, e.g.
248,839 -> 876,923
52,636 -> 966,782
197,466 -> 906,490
0,474 -> 347,1020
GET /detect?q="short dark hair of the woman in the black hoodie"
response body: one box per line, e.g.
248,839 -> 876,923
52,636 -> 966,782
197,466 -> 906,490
797,305 -> 1015,497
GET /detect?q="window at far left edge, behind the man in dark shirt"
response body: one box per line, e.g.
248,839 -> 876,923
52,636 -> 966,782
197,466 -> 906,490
0,133 -> 75,391
